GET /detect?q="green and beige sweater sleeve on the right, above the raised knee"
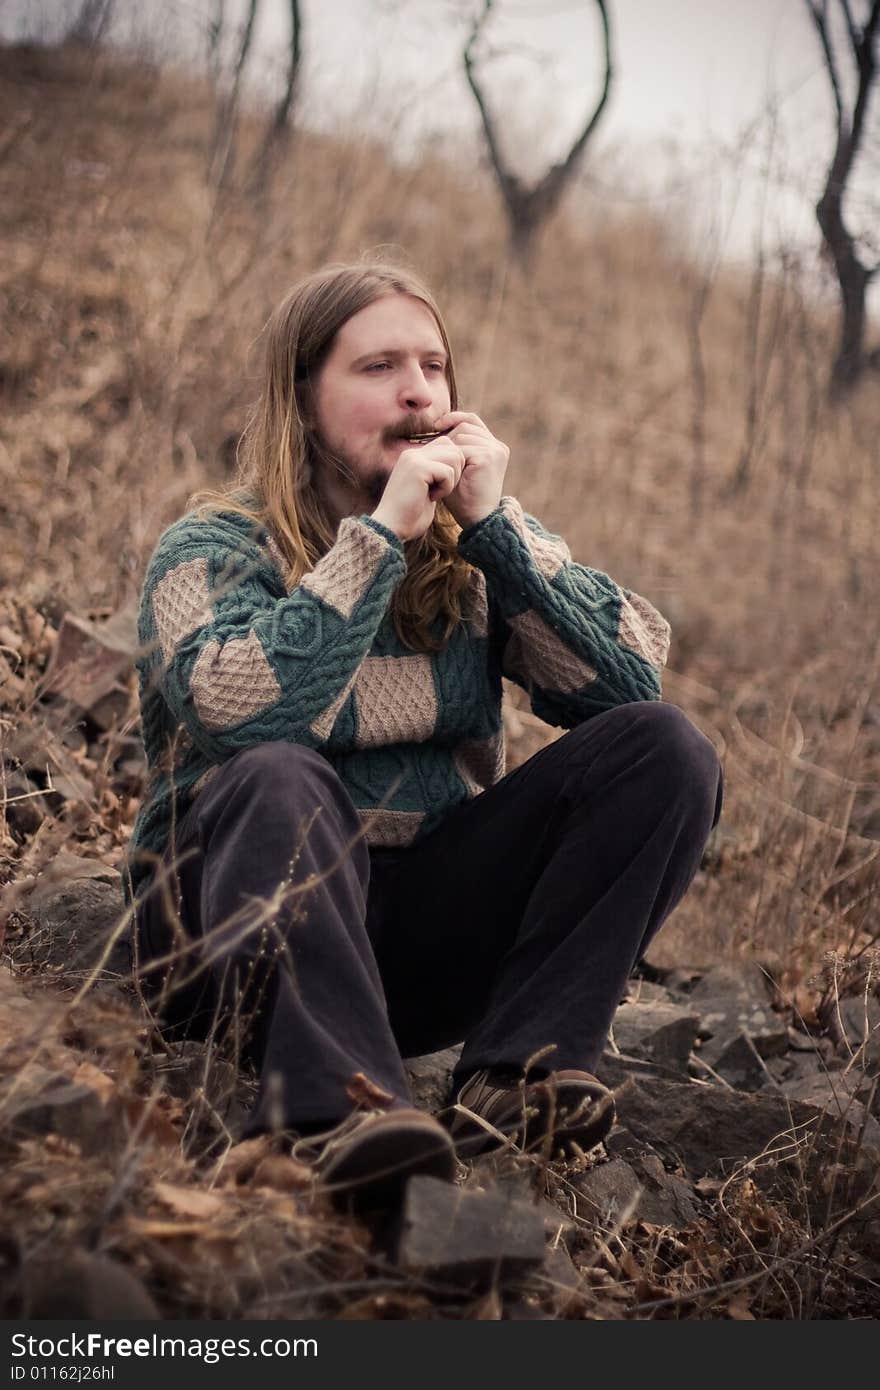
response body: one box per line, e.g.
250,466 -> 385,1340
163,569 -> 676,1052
459,498 -> 670,728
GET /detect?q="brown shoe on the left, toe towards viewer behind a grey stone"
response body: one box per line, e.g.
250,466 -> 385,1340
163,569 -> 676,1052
307,1109 -> 456,1208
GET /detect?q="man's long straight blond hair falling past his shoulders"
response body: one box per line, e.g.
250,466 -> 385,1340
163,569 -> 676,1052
190,263 -> 470,652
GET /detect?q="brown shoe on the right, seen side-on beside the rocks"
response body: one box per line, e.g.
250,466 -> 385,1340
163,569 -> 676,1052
446,1070 -> 614,1158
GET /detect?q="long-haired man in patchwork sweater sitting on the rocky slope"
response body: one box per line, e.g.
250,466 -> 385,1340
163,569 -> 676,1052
131,265 -> 722,1201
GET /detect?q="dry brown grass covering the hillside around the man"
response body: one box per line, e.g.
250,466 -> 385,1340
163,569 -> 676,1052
0,32 -> 880,1316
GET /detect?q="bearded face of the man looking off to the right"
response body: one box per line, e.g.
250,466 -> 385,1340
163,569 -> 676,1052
316,293 -> 450,516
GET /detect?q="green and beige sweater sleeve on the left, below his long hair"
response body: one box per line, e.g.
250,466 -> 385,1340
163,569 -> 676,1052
140,516 -> 406,762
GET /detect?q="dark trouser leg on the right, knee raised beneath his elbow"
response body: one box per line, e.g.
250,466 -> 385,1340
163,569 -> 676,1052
373,702 -> 722,1079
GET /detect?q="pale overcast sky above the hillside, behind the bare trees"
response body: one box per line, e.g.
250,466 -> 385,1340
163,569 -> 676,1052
6,0 -> 880,290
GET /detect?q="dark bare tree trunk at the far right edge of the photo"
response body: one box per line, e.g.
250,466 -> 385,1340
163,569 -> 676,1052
805,0 -> 880,399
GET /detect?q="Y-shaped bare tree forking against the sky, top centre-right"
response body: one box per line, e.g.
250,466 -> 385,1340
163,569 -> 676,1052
464,0 -> 613,264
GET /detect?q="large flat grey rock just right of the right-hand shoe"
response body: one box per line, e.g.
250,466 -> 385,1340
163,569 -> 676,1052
616,1077 -> 856,1177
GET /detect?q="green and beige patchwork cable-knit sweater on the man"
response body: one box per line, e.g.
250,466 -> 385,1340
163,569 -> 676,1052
129,498 -> 669,892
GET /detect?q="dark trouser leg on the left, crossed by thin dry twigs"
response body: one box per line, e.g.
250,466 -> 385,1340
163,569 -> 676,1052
142,742 -> 409,1133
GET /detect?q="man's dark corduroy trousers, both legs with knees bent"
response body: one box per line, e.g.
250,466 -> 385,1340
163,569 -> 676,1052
138,702 -> 722,1131
